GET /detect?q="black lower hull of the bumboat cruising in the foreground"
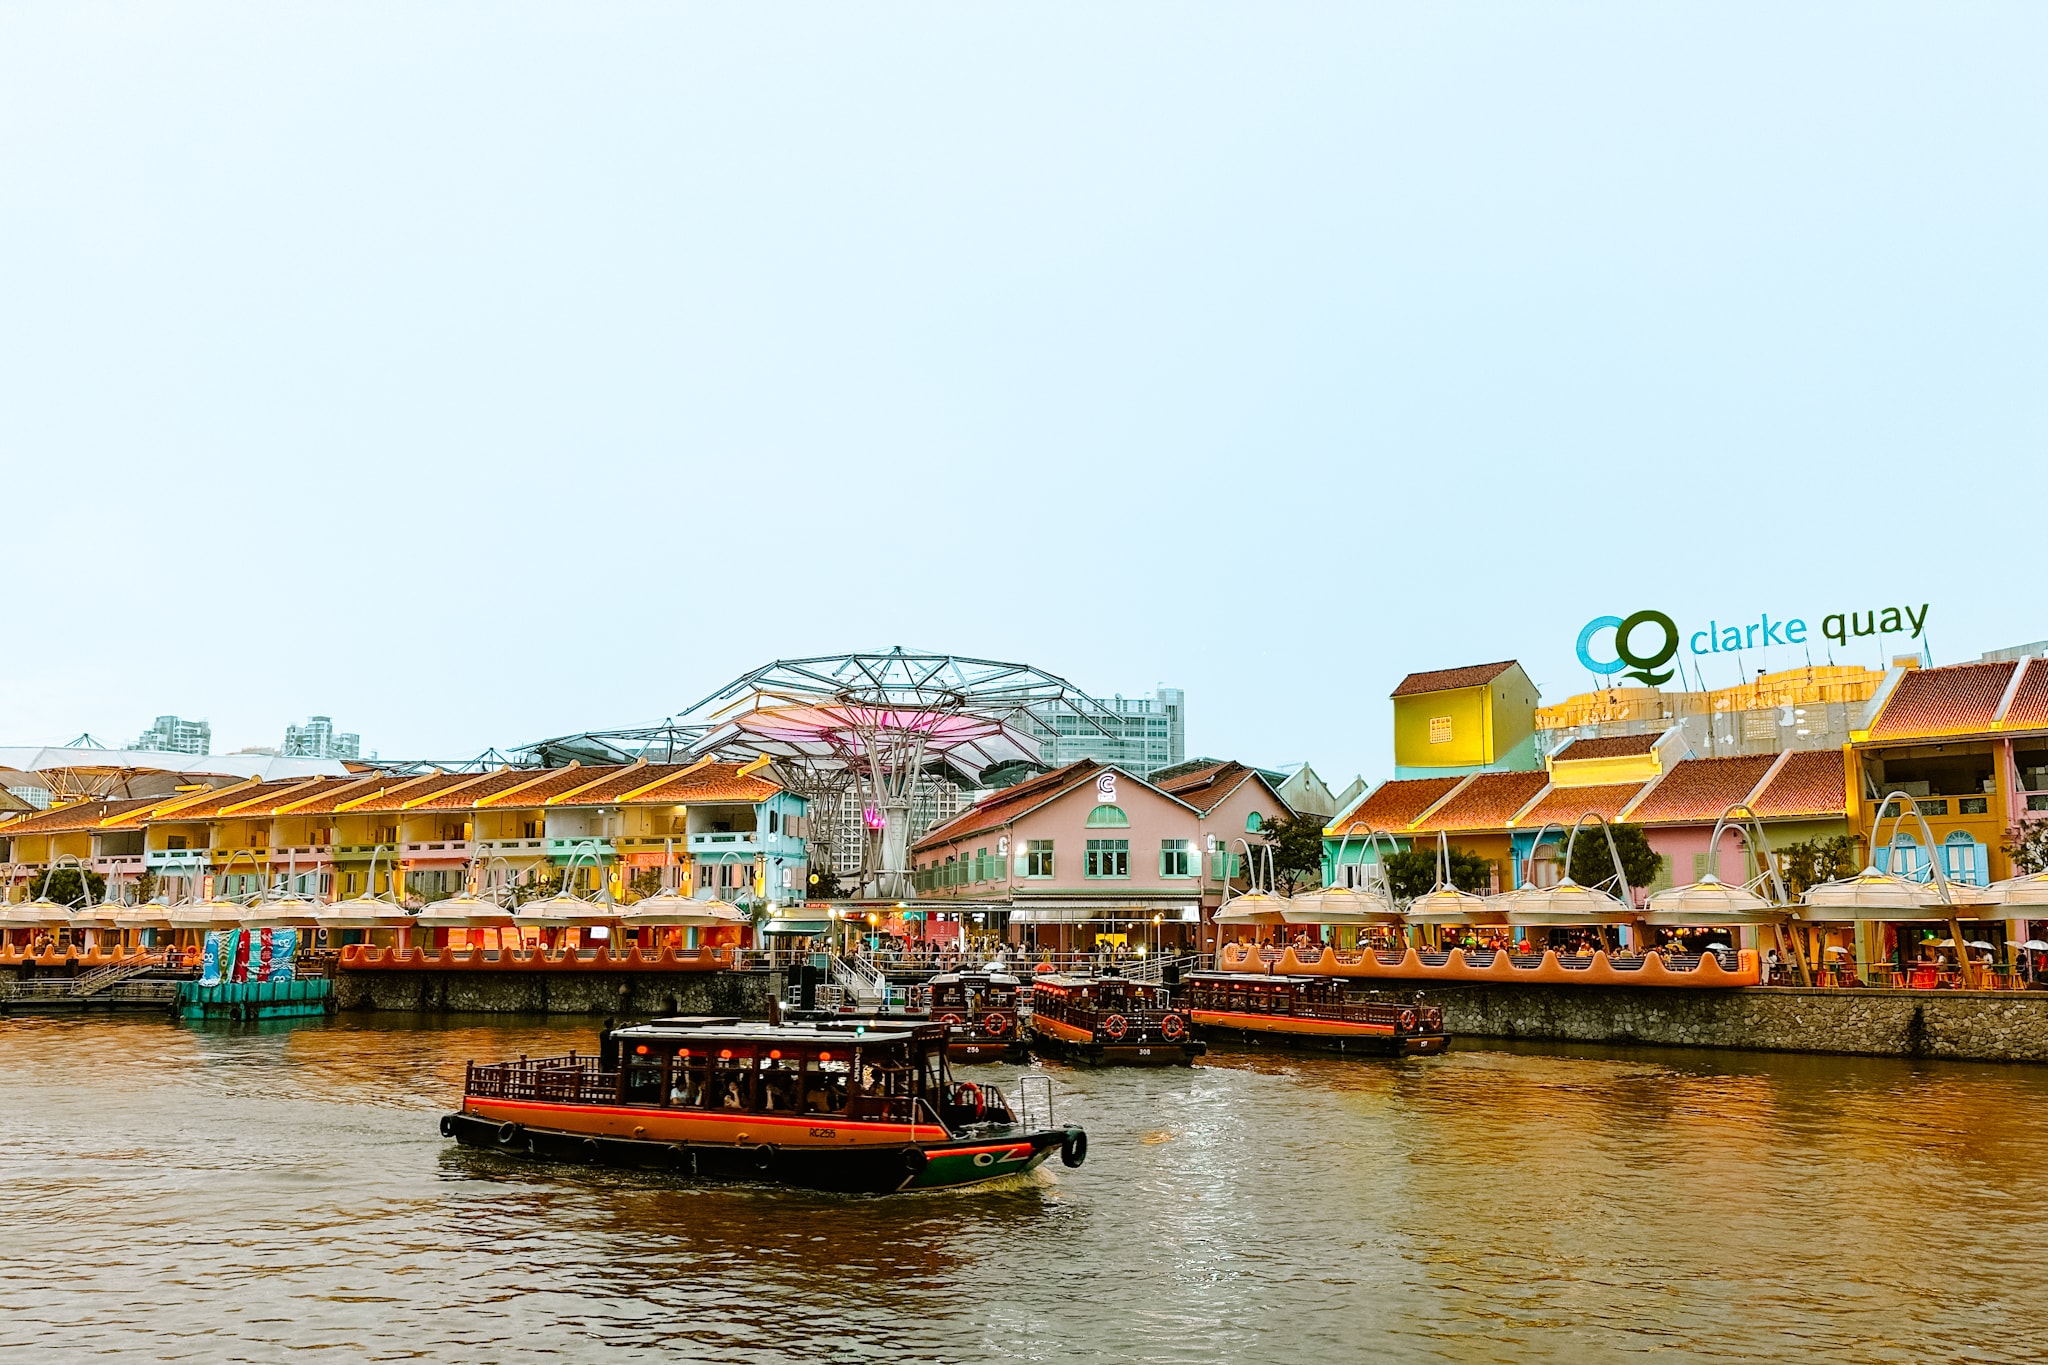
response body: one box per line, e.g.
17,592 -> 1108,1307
440,1111 -> 1087,1195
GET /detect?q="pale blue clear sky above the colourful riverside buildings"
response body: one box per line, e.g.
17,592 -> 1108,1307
0,0 -> 2048,782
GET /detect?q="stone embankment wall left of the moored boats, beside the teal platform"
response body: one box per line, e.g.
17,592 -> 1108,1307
334,970 -> 782,1019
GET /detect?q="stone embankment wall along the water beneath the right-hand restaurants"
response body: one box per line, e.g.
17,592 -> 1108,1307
1376,986 -> 2048,1062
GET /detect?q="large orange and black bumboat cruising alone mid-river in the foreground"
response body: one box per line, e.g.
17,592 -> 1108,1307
440,1017 -> 1087,1193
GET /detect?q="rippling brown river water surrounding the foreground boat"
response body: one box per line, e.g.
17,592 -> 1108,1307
0,1019 -> 2048,1363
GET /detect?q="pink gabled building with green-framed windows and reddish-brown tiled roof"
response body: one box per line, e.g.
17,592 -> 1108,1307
911,759 -> 1292,952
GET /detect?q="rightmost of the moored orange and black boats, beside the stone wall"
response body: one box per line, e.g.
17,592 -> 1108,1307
1180,972 -> 1450,1056
